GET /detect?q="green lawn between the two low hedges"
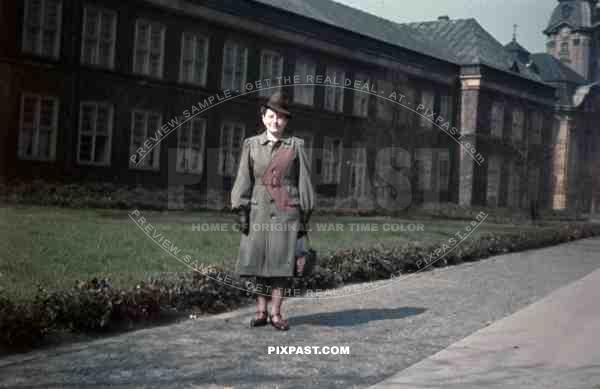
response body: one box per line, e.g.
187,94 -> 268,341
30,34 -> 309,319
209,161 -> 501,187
0,206 -> 534,300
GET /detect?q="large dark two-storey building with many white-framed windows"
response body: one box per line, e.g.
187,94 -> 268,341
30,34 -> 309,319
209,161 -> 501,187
0,0 -> 600,210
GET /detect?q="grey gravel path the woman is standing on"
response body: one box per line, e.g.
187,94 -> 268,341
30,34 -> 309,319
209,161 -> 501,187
0,238 -> 600,388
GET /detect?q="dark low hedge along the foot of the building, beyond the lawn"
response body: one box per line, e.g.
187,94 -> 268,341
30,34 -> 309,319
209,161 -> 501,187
0,179 -> 588,223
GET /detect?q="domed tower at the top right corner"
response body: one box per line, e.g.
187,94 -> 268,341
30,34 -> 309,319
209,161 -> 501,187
544,0 -> 600,81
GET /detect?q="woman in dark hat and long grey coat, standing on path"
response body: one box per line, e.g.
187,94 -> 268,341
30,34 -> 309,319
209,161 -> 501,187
231,92 -> 315,331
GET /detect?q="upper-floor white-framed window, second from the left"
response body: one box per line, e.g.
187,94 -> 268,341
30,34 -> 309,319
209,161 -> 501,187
81,7 -> 117,69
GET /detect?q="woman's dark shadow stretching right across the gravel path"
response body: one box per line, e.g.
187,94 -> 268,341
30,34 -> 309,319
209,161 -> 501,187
289,307 -> 426,327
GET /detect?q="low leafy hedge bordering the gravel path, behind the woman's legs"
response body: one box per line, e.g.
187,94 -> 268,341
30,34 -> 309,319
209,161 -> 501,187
0,223 -> 600,349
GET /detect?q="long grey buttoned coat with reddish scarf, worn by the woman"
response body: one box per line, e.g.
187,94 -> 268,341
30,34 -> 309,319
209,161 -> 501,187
231,131 -> 315,277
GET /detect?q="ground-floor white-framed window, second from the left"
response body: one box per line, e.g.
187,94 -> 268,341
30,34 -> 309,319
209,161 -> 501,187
77,102 -> 113,165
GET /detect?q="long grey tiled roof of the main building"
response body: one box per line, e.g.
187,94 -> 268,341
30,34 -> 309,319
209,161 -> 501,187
254,0 -> 541,81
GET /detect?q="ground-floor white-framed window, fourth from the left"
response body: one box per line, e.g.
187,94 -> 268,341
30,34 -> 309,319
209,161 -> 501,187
177,118 -> 206,174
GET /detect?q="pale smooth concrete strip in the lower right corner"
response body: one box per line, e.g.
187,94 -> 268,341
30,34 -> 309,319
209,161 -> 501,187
372,262 -> 600,389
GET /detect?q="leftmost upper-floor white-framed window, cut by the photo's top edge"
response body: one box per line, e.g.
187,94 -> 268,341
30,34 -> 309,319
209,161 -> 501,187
23,0 -> 62,58
